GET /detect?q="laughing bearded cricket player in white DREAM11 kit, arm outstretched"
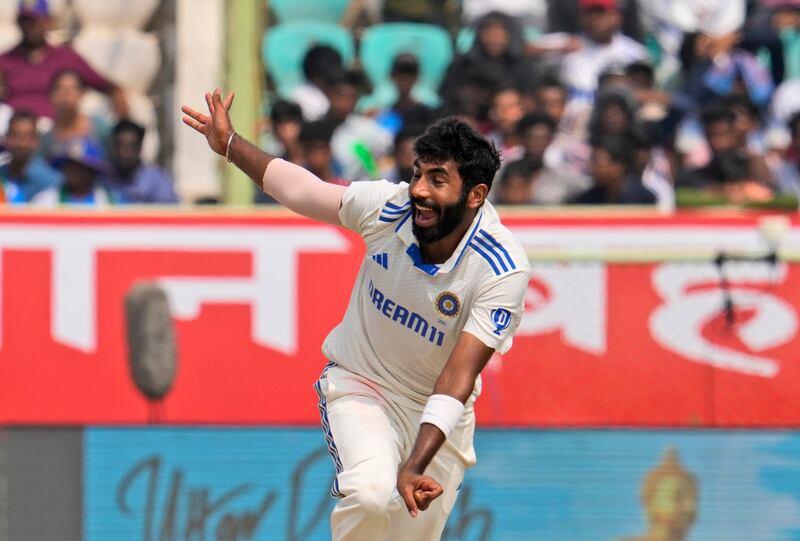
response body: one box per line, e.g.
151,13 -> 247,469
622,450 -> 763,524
182,90 -> 530,541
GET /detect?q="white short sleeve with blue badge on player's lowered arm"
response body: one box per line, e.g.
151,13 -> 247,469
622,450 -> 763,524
464,268 -> 530,354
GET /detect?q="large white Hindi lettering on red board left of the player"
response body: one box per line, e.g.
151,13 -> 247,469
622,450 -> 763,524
0,224 -> 349,355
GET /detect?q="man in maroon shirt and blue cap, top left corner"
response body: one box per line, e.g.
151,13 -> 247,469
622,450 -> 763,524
0,0 -> 128,118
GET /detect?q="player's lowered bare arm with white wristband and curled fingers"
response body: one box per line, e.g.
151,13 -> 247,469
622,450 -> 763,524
397,332 -> 494,517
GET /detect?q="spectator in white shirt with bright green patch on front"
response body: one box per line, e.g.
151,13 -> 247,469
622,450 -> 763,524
325,71 -> 392,180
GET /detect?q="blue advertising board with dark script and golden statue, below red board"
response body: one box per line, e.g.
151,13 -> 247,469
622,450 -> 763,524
84,428 -> 800,541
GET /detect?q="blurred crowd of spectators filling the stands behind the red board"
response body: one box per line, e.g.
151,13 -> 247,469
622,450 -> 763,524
0,0 -> 800,211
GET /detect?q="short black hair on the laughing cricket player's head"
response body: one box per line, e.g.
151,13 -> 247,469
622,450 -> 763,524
414,117 -> 500,193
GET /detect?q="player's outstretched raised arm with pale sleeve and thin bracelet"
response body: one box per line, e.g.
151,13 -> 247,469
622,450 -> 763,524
181,89 -> 345,225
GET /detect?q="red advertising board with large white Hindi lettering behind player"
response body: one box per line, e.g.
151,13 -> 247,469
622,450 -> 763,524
0,214 -> 800,427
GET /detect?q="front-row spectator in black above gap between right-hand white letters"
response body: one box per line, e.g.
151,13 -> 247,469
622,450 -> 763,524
571,135 -> 656,205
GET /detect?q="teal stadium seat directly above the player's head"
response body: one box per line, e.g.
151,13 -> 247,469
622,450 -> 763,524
359,23 -> 453,111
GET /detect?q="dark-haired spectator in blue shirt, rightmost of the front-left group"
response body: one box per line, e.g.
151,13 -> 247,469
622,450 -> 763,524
101,120 -> 178,205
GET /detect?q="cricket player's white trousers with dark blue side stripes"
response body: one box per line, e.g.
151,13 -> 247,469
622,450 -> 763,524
315,363 -> 475,541
